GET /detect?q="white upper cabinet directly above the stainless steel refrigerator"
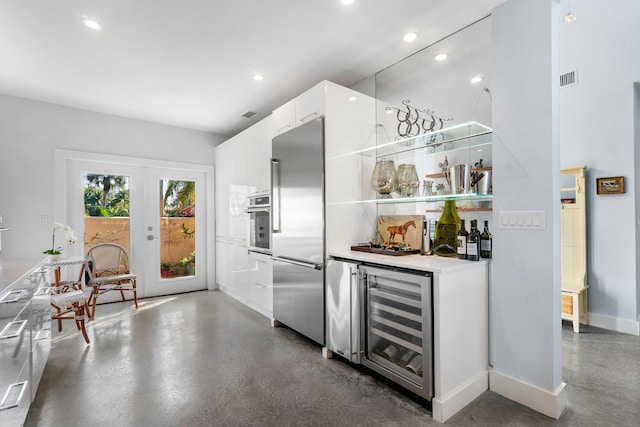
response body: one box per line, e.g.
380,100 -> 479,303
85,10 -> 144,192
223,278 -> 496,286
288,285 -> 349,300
271,82 -> 325,136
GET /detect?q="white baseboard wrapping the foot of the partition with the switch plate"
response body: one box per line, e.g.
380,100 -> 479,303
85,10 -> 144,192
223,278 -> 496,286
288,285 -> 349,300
489,370 -> 567,419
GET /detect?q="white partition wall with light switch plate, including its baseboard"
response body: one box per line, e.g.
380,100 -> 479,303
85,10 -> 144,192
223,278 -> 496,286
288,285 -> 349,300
490,0 -> 566,417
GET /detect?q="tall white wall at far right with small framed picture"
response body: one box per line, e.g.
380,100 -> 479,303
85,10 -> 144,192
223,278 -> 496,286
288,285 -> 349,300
560,0 -> 640,335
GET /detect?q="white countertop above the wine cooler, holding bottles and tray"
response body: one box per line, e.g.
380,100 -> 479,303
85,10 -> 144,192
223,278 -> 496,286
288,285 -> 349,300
329,250 -> 488,273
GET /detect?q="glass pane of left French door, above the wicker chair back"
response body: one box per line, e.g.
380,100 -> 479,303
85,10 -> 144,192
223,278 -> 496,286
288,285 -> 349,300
84,174 -> 130,251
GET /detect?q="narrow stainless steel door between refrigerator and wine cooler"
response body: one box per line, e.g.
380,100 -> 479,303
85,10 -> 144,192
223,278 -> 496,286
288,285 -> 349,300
325,258 -> 360,364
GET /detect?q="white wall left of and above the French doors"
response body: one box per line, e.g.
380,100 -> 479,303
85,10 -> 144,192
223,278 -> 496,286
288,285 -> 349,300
0,95 -> 222,257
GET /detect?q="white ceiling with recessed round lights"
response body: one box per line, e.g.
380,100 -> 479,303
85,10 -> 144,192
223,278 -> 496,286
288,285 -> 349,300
0,0 -> 505,136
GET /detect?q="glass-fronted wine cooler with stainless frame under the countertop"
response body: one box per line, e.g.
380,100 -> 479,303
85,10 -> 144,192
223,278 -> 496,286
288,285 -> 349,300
359,265 -> 433,400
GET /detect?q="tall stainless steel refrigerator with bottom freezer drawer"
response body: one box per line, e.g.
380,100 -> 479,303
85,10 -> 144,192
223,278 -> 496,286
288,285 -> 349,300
271,117 -> 325,344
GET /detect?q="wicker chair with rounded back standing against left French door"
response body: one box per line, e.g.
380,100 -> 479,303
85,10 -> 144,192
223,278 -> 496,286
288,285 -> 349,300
87,243 -> 138,319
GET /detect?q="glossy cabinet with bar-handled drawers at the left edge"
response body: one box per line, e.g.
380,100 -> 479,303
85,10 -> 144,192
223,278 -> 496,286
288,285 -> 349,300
0,259 -> 51,426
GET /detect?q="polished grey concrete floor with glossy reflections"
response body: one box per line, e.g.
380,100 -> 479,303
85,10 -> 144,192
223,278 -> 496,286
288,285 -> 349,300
25,291 -> 640,427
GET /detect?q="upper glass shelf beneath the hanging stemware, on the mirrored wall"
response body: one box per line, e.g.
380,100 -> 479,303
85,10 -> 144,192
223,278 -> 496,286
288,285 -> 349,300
354,122 -> 493,158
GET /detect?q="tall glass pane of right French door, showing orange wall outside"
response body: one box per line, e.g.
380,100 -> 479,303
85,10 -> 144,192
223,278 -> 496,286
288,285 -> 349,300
159,179 -> 196,278
